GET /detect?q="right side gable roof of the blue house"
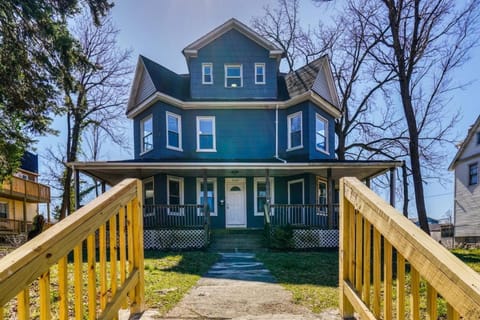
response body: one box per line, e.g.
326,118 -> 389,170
279,55 -> 339,109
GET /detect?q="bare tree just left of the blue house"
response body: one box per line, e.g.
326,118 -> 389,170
50,11 -> 132,219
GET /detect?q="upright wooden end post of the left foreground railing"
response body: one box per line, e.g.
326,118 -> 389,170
130,181 -> 145,314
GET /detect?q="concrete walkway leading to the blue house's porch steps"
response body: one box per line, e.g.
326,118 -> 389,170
133,253 -> 340,320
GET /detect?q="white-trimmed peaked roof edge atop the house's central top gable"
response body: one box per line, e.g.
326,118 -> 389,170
182,18 -> 284,59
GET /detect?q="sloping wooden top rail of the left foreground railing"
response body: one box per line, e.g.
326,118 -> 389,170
0,179 -> 137,305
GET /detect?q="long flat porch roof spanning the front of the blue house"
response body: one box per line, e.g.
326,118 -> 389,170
68,160 -> 402,185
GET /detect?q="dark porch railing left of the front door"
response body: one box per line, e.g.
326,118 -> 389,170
143,204 -> 206,229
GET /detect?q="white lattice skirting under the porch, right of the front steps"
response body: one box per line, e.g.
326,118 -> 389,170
293,229 -> 339,249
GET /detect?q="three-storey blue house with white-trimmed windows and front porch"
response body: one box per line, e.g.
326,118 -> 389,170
72,19 -> 399,247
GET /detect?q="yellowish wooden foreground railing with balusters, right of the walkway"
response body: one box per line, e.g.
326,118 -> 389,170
339,178 -> 480,320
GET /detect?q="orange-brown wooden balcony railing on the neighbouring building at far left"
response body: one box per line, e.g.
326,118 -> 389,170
0,176 -> 50,203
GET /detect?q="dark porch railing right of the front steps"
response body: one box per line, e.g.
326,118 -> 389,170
267,204 -> 338,229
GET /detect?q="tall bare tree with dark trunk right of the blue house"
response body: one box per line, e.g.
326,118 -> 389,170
363,0 -> 479,232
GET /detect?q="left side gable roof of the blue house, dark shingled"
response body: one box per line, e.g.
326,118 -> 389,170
126,55 -> 190,114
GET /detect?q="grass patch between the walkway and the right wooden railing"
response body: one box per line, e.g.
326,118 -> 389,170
257,251 -> 339,313
